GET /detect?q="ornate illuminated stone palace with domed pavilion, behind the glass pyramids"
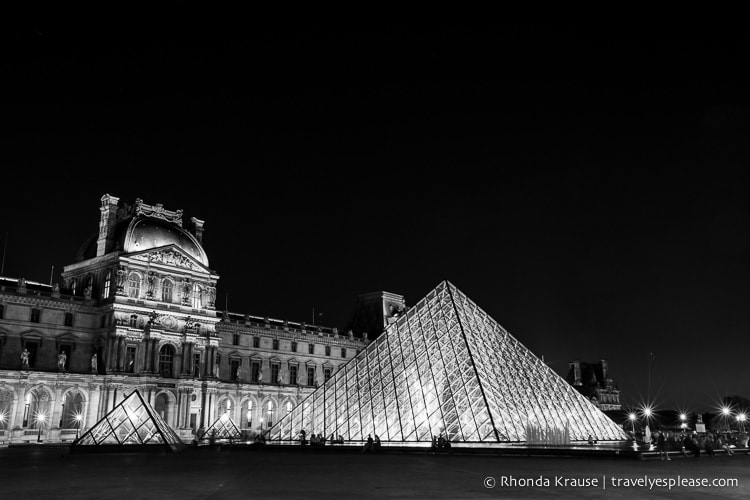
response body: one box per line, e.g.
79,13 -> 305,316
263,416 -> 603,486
0,195 -> 378,444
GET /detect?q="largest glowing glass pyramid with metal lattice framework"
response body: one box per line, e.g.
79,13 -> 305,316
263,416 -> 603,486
270,281 -> 627,444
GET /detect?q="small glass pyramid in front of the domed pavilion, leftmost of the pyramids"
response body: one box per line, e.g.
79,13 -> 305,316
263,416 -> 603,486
72,390 -> 183,446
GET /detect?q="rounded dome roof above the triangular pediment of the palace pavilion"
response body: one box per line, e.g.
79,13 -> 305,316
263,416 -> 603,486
119,216 -> 208,267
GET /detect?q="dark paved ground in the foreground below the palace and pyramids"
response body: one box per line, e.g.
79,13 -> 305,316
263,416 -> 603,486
0,446 -> 750,500
